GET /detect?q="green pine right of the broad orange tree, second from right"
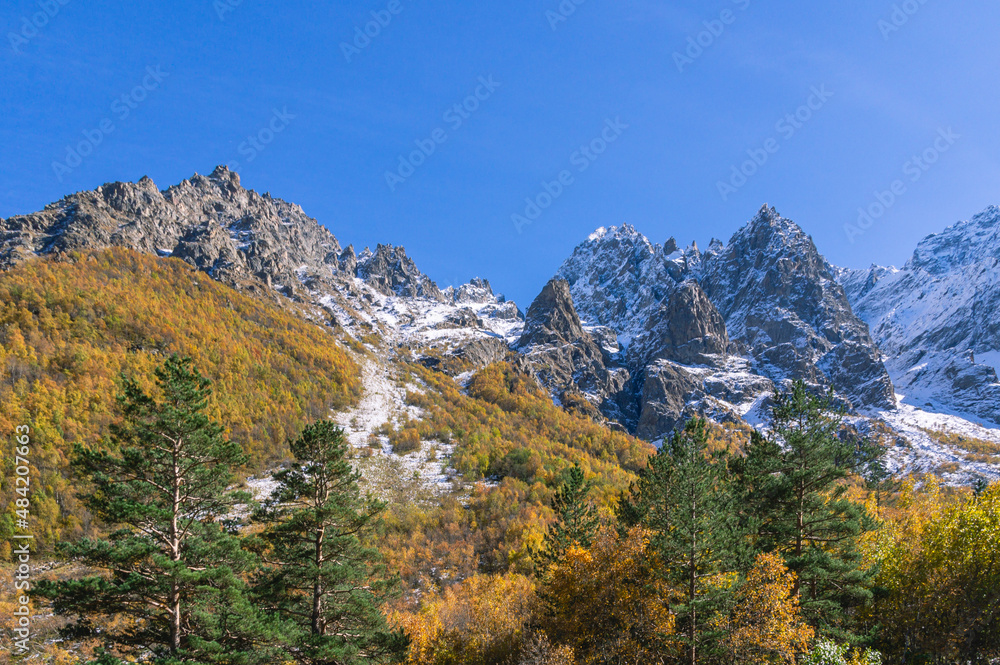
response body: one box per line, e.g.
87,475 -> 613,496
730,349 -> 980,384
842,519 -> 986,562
619,419 -> 738,665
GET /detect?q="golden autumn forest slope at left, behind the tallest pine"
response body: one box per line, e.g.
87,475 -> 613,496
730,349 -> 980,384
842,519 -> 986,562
0,249 -> 361,548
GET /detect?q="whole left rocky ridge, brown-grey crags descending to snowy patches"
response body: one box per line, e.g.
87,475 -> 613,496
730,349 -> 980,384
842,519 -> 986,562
0,166 -> 520,355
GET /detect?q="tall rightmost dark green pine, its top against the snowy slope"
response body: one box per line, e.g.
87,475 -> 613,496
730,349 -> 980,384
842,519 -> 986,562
738,381 -> 883,638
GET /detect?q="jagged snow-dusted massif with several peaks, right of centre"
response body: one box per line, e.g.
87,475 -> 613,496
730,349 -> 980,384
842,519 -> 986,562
540,206 -> 895,438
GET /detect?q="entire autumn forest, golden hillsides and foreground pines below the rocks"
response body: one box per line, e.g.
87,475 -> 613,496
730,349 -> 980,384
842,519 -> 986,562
0,250 -> 1000,665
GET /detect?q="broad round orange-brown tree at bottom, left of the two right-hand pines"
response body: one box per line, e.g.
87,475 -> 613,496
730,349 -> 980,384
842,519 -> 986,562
544,527 -> 677,664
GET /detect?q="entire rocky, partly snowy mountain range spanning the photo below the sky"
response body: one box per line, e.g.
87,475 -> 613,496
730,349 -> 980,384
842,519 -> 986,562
0,167 -> 1000,475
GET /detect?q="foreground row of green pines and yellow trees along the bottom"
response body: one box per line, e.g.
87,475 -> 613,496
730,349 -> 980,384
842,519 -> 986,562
25,357 -> 1000,665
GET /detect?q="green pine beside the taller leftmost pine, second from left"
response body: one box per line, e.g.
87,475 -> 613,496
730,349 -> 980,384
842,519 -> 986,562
257,420 -> 406,665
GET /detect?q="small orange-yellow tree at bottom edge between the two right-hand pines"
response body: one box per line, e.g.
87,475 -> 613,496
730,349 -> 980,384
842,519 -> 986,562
716,554 -> 813,664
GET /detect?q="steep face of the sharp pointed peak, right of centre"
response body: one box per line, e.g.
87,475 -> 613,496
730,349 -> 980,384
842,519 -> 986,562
699,207 -> 895,408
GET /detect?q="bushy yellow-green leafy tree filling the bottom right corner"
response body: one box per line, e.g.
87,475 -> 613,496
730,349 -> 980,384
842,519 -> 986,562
868,483 -> 1000,662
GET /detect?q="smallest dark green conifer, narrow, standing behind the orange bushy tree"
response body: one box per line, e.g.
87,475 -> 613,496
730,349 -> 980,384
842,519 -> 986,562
537,464 -> 600,572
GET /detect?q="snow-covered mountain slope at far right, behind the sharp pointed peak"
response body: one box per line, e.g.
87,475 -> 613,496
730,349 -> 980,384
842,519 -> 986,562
838,206 -> 1000,425
